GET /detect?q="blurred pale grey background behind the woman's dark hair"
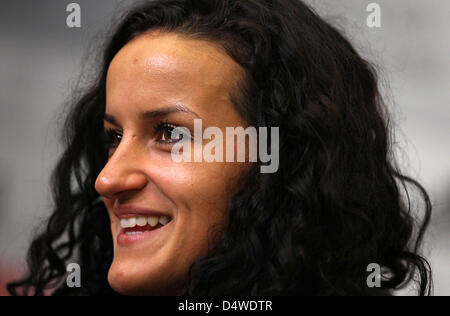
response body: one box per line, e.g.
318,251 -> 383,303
0,0 -> 450,295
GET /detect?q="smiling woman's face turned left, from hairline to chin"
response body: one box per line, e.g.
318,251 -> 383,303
96,32 -> 248,295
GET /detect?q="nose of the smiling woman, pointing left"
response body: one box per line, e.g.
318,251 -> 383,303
95,141 -> 148,199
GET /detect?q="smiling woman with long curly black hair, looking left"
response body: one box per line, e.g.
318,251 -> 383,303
9,0 -> 431,295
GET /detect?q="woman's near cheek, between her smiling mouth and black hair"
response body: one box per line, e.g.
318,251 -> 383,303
157,159 -> 243,243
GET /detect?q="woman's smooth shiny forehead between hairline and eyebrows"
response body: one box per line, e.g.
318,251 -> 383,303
107,32 -> 241,112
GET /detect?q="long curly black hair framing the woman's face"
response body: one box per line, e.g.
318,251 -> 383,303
8,0 -> 432,295
